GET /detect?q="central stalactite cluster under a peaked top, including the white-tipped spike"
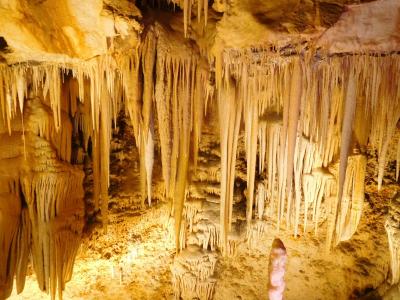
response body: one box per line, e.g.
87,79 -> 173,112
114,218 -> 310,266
119,26 -> 210,249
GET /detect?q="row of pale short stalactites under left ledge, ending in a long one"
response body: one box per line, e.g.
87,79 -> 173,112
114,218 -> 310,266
0,55 -> 123,231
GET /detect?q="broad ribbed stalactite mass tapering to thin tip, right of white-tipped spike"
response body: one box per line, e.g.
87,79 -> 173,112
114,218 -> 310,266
151,27 -> 207,249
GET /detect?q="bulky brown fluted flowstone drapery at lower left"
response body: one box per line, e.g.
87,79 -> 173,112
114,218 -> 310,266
21,136 -> 84,299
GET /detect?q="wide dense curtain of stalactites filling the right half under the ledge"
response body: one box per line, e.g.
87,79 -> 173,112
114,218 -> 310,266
215,51 -> 400,248
